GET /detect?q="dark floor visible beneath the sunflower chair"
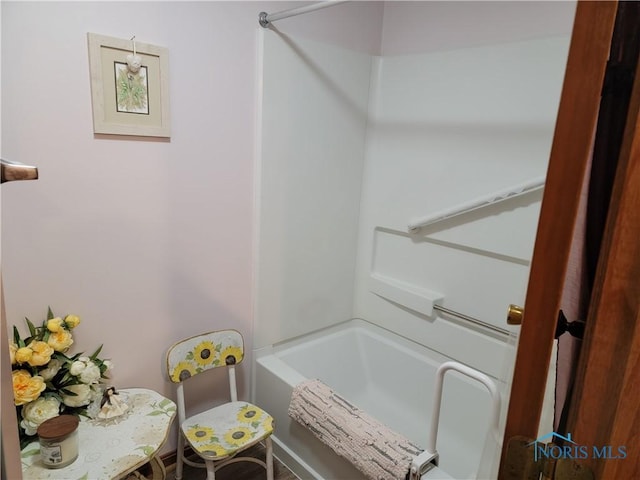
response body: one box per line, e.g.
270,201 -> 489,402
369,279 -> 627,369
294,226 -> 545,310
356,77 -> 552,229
162,445 -> 298,480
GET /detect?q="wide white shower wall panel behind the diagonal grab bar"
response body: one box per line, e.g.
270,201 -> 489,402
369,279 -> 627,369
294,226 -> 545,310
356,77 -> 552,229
355,36 -> 568,377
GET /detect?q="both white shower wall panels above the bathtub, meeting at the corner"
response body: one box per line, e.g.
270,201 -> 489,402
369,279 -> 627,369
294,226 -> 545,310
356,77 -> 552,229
254,31 -> 568,378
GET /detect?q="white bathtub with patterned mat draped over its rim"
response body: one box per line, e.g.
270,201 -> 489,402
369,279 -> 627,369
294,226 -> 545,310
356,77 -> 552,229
253,319 -> 503,480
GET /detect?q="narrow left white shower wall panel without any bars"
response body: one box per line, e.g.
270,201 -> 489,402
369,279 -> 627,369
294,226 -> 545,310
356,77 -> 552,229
254,31 -> 371,347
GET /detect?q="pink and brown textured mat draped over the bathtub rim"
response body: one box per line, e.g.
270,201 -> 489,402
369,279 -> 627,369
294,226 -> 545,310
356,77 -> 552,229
289,380 -> 422,480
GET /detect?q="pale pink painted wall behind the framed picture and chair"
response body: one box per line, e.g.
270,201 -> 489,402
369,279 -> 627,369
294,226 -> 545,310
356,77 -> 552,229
0,1 -> 382,462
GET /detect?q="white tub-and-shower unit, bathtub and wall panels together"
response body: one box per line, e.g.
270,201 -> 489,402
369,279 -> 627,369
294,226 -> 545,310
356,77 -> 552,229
252,20 -> 568,478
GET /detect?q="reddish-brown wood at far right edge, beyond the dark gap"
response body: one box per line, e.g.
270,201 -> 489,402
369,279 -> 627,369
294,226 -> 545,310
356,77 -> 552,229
568,32 -> 640,479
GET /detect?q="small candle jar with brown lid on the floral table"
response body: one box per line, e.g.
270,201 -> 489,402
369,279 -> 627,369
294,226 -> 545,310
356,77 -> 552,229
38,415 -> 79,468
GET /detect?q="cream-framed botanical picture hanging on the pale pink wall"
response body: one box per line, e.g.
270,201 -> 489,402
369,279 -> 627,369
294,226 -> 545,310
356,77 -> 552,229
87,33 -> 171,137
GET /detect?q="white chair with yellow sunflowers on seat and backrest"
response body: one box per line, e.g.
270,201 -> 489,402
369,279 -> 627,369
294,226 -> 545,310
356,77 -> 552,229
167,330 -> 273,480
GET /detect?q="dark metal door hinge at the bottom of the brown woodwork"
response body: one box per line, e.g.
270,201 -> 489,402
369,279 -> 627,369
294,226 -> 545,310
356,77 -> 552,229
500,436 -> 595,480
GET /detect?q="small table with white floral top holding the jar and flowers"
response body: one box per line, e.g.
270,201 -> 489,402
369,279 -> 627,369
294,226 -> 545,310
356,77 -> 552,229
21,388 -> 176,480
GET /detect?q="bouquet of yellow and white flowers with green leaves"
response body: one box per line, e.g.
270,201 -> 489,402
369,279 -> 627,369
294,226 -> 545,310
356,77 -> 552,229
9,308 -> 112,447
